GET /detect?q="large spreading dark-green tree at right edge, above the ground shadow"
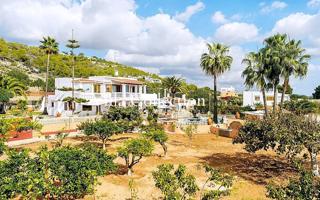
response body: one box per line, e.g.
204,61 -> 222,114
233,113 -> 320,176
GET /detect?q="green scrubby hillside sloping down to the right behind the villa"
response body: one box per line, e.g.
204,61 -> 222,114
0,38 -> 159,80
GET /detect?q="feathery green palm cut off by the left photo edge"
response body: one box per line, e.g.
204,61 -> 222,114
0,76 -> 27,114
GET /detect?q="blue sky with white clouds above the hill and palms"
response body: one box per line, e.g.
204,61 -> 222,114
0,0 -> 320,95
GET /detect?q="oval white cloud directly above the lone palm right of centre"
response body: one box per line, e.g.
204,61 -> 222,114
214,22 -> 259,45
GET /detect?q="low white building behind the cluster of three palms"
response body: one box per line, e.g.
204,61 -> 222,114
243,91 -> 290,106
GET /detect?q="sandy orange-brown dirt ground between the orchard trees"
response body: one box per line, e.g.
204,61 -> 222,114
18,130 -> 295,200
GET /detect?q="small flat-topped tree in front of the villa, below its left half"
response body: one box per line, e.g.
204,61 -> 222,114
78,120 -> 123,149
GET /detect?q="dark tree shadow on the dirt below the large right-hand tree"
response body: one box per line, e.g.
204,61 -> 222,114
200,153 -> 296,185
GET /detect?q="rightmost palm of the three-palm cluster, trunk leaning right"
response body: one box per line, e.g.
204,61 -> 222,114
280,40 -> 310,109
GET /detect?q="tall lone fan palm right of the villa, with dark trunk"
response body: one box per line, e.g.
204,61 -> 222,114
200,43 -> 233,123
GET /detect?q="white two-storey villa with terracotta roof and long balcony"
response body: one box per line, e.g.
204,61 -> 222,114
47,76 -> 159,116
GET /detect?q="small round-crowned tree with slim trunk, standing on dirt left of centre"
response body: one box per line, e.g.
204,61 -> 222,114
118,138 -> 154,176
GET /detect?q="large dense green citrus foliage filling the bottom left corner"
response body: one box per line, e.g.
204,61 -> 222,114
0,146 -> 116,199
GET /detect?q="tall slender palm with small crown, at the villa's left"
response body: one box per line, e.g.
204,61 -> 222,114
39,36 -> 59,115
